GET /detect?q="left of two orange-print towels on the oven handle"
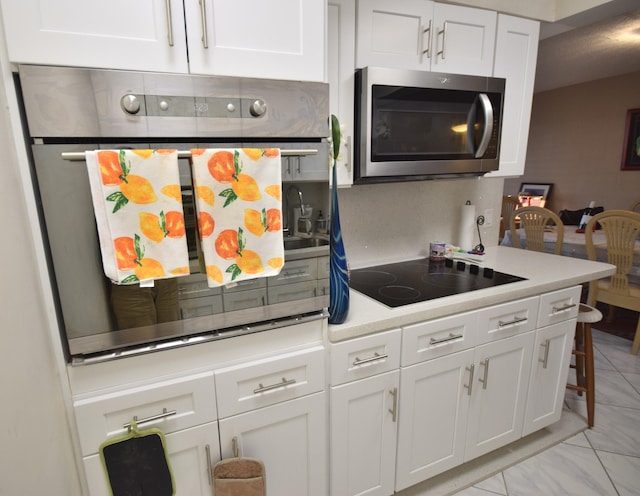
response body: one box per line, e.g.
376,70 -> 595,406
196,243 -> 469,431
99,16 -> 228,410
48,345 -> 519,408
85,149 -> 189,286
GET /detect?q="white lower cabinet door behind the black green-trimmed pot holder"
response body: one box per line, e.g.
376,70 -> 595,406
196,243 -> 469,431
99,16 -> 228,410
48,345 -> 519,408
84,422 -> 220,496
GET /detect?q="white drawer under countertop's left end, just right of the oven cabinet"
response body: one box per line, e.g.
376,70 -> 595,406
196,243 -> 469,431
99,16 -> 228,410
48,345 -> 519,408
330,329 -> 401,386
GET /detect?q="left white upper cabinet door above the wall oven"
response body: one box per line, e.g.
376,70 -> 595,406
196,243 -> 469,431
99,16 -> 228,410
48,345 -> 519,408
2,0 -> 188,73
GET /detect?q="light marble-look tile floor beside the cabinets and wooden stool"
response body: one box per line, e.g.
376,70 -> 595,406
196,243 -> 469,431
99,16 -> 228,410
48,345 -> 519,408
455,329 -> 640,496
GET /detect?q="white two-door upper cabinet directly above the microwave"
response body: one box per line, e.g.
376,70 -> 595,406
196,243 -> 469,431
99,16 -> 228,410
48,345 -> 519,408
356,0 -> 497,76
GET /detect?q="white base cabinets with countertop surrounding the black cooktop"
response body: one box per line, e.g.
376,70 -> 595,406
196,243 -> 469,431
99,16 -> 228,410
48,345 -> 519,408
327,247 -> 615,496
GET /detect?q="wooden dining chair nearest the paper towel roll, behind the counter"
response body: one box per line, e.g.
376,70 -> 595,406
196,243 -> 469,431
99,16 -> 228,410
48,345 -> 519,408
510,207 -> 564,255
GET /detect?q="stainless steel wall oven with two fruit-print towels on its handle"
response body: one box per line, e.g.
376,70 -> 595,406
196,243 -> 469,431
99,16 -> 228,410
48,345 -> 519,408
16,66 -> 329,363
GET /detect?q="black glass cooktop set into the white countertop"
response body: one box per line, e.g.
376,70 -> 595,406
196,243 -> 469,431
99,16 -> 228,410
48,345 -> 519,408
349,258 -> 525,307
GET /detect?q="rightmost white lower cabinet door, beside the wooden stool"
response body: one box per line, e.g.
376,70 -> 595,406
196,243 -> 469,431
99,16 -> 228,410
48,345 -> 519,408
522,319 -> 576,436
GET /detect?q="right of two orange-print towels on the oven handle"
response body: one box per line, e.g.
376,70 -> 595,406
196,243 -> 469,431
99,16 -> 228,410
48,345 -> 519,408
191,148 -> 284,287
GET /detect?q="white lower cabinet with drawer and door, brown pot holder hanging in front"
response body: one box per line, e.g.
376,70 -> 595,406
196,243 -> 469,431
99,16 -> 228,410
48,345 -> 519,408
216,346 -> 329,496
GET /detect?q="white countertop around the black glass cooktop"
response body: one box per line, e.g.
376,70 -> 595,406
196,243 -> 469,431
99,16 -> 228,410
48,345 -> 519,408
329,246 -> 615,342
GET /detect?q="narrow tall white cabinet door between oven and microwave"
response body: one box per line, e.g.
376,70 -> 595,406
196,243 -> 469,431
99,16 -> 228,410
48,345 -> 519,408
327,0 -> 356,186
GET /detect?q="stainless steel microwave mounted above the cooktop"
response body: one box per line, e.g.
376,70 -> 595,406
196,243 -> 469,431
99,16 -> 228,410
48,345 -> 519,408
354,67 -> 505,183
